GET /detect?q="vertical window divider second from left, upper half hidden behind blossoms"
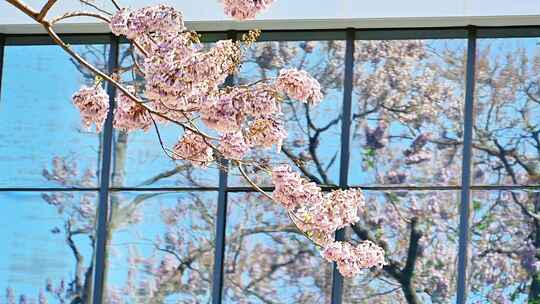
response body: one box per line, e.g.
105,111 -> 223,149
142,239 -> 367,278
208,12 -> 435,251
212,30 -> 236,304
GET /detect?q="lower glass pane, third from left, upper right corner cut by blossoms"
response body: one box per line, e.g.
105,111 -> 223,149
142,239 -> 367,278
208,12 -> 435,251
223,193 -> 332,304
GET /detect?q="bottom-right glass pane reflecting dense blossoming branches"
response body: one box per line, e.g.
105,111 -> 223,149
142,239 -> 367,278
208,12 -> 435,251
468,190 -> 540,303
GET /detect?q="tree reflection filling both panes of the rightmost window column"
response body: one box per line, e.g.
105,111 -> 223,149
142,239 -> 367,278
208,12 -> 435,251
464,39 -> 540,303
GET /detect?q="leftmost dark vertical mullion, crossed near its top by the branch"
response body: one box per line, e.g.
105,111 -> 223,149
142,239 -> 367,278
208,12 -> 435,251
92,35 -> 119,304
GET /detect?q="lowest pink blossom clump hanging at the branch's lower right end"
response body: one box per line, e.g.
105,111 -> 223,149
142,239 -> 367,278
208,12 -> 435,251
272,165 -> 385,277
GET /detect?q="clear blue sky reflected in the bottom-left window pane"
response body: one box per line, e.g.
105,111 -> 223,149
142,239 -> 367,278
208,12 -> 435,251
0,192 -> 92,303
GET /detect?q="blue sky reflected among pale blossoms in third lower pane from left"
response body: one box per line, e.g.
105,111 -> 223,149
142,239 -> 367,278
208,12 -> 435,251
224,193 -> 331,304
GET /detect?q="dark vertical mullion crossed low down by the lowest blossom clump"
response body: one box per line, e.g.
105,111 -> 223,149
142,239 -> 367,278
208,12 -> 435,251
331,28 -> 355,304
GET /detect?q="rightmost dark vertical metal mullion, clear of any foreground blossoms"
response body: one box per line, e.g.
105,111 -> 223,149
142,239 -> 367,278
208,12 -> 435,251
457,26 -> 476,304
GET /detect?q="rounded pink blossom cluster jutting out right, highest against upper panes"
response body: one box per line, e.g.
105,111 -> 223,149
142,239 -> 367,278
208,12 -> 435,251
276,69 -> 323,105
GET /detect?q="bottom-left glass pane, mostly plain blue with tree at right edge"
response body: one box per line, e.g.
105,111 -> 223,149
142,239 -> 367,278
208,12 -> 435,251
0,192 -> 97,304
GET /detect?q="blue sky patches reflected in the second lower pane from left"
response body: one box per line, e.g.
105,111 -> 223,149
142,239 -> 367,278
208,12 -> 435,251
107,192 -> 217,303
